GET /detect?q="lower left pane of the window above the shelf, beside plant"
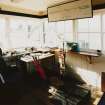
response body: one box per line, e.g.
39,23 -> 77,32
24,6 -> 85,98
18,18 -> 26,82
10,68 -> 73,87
78,33 -> 89,49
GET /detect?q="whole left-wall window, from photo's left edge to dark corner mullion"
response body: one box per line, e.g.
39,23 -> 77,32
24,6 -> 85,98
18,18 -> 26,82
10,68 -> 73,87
0,15 -> 43,49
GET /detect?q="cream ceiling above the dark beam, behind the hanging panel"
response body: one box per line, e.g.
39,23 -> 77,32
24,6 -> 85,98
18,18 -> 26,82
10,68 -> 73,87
0,0 -> 105,16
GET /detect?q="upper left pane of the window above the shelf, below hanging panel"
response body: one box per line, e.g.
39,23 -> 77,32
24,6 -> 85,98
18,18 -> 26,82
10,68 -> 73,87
77,19 -> 89,32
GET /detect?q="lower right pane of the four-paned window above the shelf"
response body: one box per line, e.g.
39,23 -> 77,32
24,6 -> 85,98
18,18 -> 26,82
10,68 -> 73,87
89,33 -> 101,50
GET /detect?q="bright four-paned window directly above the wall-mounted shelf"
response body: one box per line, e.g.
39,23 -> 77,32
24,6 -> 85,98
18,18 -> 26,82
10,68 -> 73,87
77,15 -> 101,50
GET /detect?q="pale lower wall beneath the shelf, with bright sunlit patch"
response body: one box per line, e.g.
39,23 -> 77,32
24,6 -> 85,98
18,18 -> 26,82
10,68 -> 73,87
66,53 -> 105,88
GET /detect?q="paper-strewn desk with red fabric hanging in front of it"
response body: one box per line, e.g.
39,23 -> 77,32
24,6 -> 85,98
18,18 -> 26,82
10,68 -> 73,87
20,53 -> 55,73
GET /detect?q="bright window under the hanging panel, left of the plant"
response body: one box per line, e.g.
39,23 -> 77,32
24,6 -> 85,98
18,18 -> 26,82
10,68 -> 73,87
45,20 -> 73,47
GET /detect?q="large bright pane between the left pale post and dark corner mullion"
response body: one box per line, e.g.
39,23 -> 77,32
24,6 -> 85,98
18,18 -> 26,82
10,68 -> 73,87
10,18 -> 43,48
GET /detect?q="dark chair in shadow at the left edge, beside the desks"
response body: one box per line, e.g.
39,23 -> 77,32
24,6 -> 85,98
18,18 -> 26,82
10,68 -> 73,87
0,56 -> 23,105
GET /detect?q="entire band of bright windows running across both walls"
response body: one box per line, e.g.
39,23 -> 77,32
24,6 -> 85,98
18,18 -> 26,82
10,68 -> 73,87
0,9 -> 105,51
